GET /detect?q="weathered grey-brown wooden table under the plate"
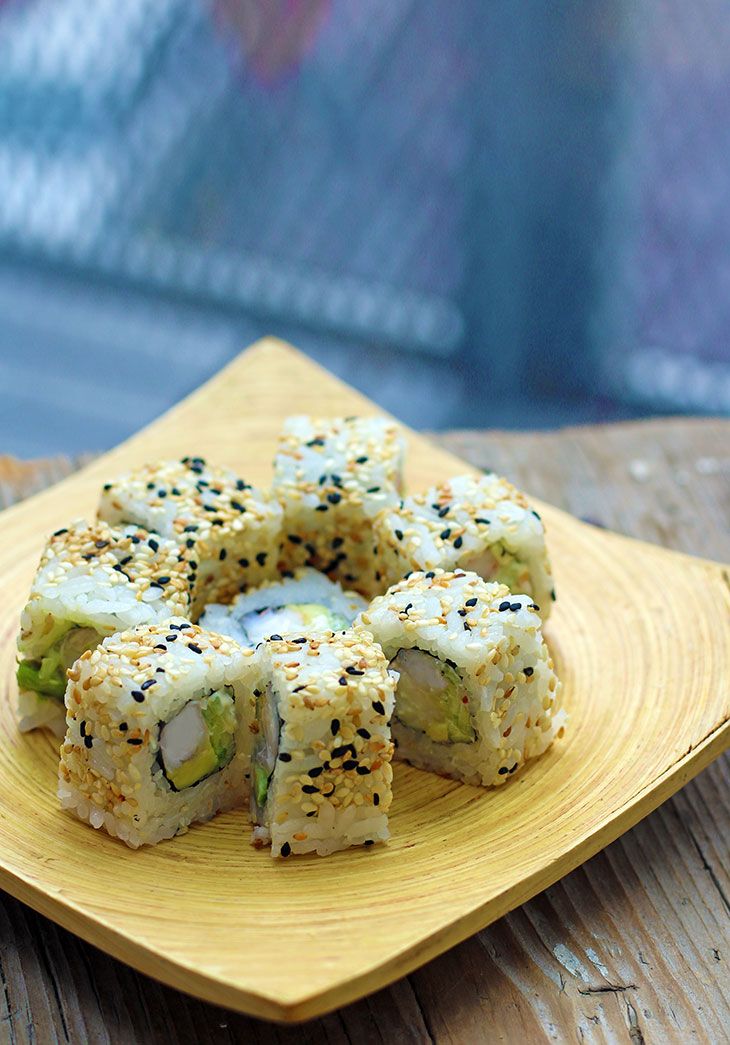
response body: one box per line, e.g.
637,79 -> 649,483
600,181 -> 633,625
0,420 -> 730,1045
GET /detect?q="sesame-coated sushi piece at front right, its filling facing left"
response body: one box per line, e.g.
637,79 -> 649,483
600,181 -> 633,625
356,570 -> 565,787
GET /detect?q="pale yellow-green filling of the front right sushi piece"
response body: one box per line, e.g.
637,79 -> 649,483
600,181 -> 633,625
391,649 -> 476,744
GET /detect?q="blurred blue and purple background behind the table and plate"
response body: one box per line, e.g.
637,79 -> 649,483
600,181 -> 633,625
0,0 -> 730,457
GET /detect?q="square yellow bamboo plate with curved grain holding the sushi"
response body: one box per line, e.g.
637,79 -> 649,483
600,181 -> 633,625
0,339 -> 730,1020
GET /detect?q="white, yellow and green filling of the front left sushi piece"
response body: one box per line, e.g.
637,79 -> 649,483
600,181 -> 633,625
160,687 -> 236,791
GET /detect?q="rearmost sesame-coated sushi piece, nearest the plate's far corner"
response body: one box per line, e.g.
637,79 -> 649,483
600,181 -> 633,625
274,416 -> 403,597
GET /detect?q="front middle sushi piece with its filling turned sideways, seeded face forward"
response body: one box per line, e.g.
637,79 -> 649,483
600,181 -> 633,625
252,631 -> 395,857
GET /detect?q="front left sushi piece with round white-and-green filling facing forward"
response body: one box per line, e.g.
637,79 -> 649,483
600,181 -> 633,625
58,618 -> 260,849
